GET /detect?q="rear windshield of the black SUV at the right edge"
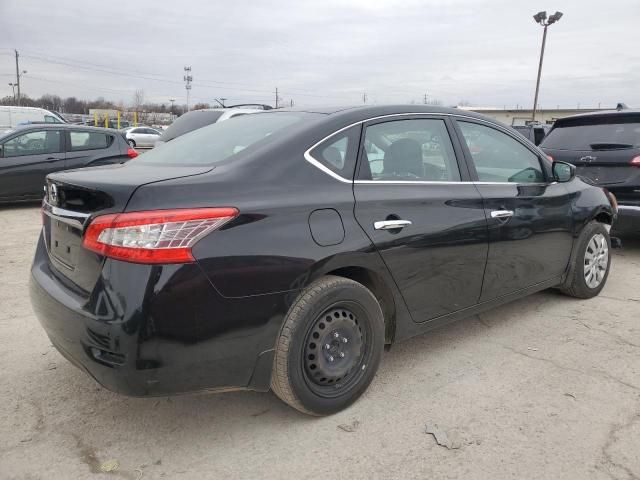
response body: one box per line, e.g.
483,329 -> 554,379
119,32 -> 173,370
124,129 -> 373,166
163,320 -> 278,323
541,116 -> 640,150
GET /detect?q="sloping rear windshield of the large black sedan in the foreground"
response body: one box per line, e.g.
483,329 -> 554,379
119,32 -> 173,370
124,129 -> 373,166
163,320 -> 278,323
136,112 -> 317,165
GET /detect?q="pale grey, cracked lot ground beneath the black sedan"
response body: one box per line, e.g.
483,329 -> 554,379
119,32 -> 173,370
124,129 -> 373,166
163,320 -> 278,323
0,206 -> 640,480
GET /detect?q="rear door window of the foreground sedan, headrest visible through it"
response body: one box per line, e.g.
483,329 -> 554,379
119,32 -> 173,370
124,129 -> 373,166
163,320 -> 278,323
358,119 -> 460,181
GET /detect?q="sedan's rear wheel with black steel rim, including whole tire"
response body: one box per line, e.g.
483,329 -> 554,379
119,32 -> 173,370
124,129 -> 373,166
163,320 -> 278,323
271,276 -> 384,416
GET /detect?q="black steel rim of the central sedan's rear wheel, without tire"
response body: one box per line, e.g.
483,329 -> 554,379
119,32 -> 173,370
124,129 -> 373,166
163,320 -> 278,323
304,308 -> 363,386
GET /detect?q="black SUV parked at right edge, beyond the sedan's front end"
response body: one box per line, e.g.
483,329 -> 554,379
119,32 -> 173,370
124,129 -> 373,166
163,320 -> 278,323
540,105 -> 640,233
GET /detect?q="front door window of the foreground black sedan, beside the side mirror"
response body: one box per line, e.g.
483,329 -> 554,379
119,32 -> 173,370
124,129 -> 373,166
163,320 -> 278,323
458,121 -> 545,183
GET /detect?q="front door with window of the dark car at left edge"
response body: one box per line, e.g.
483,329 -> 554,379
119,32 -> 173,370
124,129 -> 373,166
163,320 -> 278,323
0,128 -> 65,200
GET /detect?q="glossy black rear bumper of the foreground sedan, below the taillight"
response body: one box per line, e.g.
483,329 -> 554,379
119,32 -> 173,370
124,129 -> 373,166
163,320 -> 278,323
30,234 -> 286,396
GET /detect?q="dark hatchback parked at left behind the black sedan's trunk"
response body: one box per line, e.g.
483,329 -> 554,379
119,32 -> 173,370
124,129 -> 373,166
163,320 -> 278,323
0,123 -> 138,203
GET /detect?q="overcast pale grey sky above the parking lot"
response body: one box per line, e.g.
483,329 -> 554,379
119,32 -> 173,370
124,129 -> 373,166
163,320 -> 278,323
0,0 -> 640,108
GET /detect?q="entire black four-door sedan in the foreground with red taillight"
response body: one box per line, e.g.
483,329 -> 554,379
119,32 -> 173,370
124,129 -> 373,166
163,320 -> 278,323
31,106 -> 616,415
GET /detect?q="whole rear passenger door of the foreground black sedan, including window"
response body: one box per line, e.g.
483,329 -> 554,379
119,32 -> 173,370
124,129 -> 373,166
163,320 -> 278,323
354,116 -> 487,322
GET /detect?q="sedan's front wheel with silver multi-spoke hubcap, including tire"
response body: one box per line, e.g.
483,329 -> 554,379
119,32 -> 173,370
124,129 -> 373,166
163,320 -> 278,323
560,221 -> 611,298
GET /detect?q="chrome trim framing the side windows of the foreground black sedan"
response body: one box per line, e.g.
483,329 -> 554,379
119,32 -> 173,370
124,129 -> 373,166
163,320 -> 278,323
304,112 -> 536,185
